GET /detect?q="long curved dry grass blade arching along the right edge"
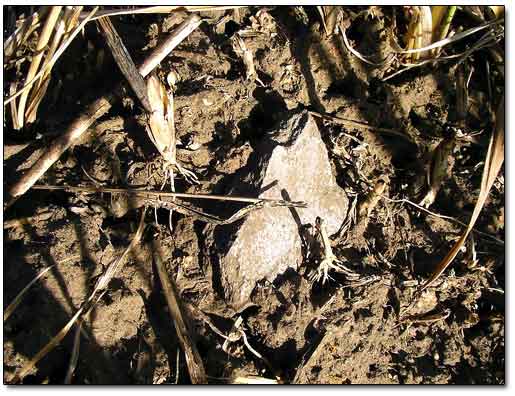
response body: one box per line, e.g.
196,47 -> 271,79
418,96 -> 504,294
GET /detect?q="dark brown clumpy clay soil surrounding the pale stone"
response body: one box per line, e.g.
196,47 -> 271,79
3,7 -> 505,384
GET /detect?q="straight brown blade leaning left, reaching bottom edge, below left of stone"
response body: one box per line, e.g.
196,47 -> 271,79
154,243 -> 207,384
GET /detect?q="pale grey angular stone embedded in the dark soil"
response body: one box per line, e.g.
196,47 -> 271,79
215,111 -> 348,308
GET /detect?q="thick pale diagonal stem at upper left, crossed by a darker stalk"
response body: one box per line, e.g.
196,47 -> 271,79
6,15 -> 201,208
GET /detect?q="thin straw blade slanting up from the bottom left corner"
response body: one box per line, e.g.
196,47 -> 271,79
12,210 -> 146,383
